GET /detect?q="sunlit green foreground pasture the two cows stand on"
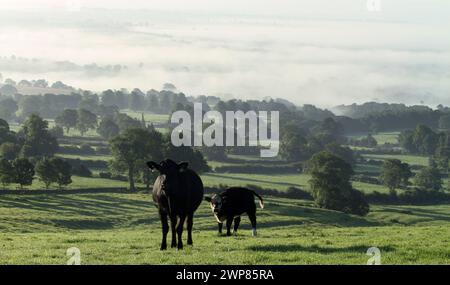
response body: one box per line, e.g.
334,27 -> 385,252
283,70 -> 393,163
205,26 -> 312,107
0,193 -> 450,264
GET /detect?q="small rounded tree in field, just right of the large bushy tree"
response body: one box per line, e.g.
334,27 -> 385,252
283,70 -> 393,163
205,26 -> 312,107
380,159 -> 413,195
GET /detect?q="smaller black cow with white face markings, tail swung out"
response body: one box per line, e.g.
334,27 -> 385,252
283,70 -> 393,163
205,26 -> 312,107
205,187 -> 264,236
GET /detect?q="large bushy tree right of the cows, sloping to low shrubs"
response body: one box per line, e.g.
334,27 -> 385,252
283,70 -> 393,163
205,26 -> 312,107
308,151 -> 369,215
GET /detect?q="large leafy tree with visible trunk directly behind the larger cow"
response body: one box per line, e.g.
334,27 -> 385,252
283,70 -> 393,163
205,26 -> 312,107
109,128 -> 162,190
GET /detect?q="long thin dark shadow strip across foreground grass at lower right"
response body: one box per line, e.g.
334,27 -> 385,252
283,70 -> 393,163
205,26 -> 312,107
248,244 -> 395,254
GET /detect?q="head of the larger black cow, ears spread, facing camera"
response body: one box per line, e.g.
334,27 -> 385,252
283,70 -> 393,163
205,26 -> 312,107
147,159 -> 189,194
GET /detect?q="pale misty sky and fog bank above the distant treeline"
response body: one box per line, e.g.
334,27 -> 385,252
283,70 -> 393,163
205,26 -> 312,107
0,0 -> 450,107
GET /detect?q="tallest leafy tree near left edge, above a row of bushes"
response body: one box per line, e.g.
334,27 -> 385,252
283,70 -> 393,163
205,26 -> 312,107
19,114 -> 58,157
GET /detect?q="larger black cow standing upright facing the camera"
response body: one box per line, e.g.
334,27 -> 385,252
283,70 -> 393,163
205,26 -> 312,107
147,159 -> 203,250
